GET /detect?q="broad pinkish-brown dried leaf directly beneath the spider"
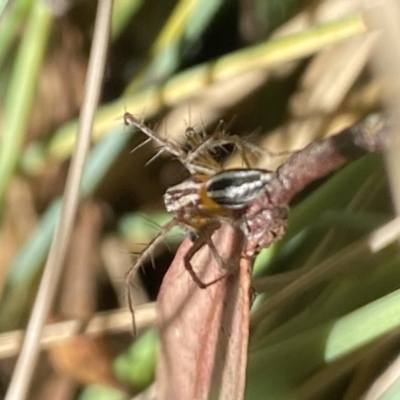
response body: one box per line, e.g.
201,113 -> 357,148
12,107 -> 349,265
157,225 -> 251,400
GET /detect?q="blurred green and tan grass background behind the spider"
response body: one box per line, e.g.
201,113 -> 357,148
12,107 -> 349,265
0,0 -> 400,400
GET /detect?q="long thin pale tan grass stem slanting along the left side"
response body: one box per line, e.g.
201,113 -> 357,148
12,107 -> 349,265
6,0 -> 112,400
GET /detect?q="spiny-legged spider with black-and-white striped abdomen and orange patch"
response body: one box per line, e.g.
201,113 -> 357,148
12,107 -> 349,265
124,112 -> 284,311
